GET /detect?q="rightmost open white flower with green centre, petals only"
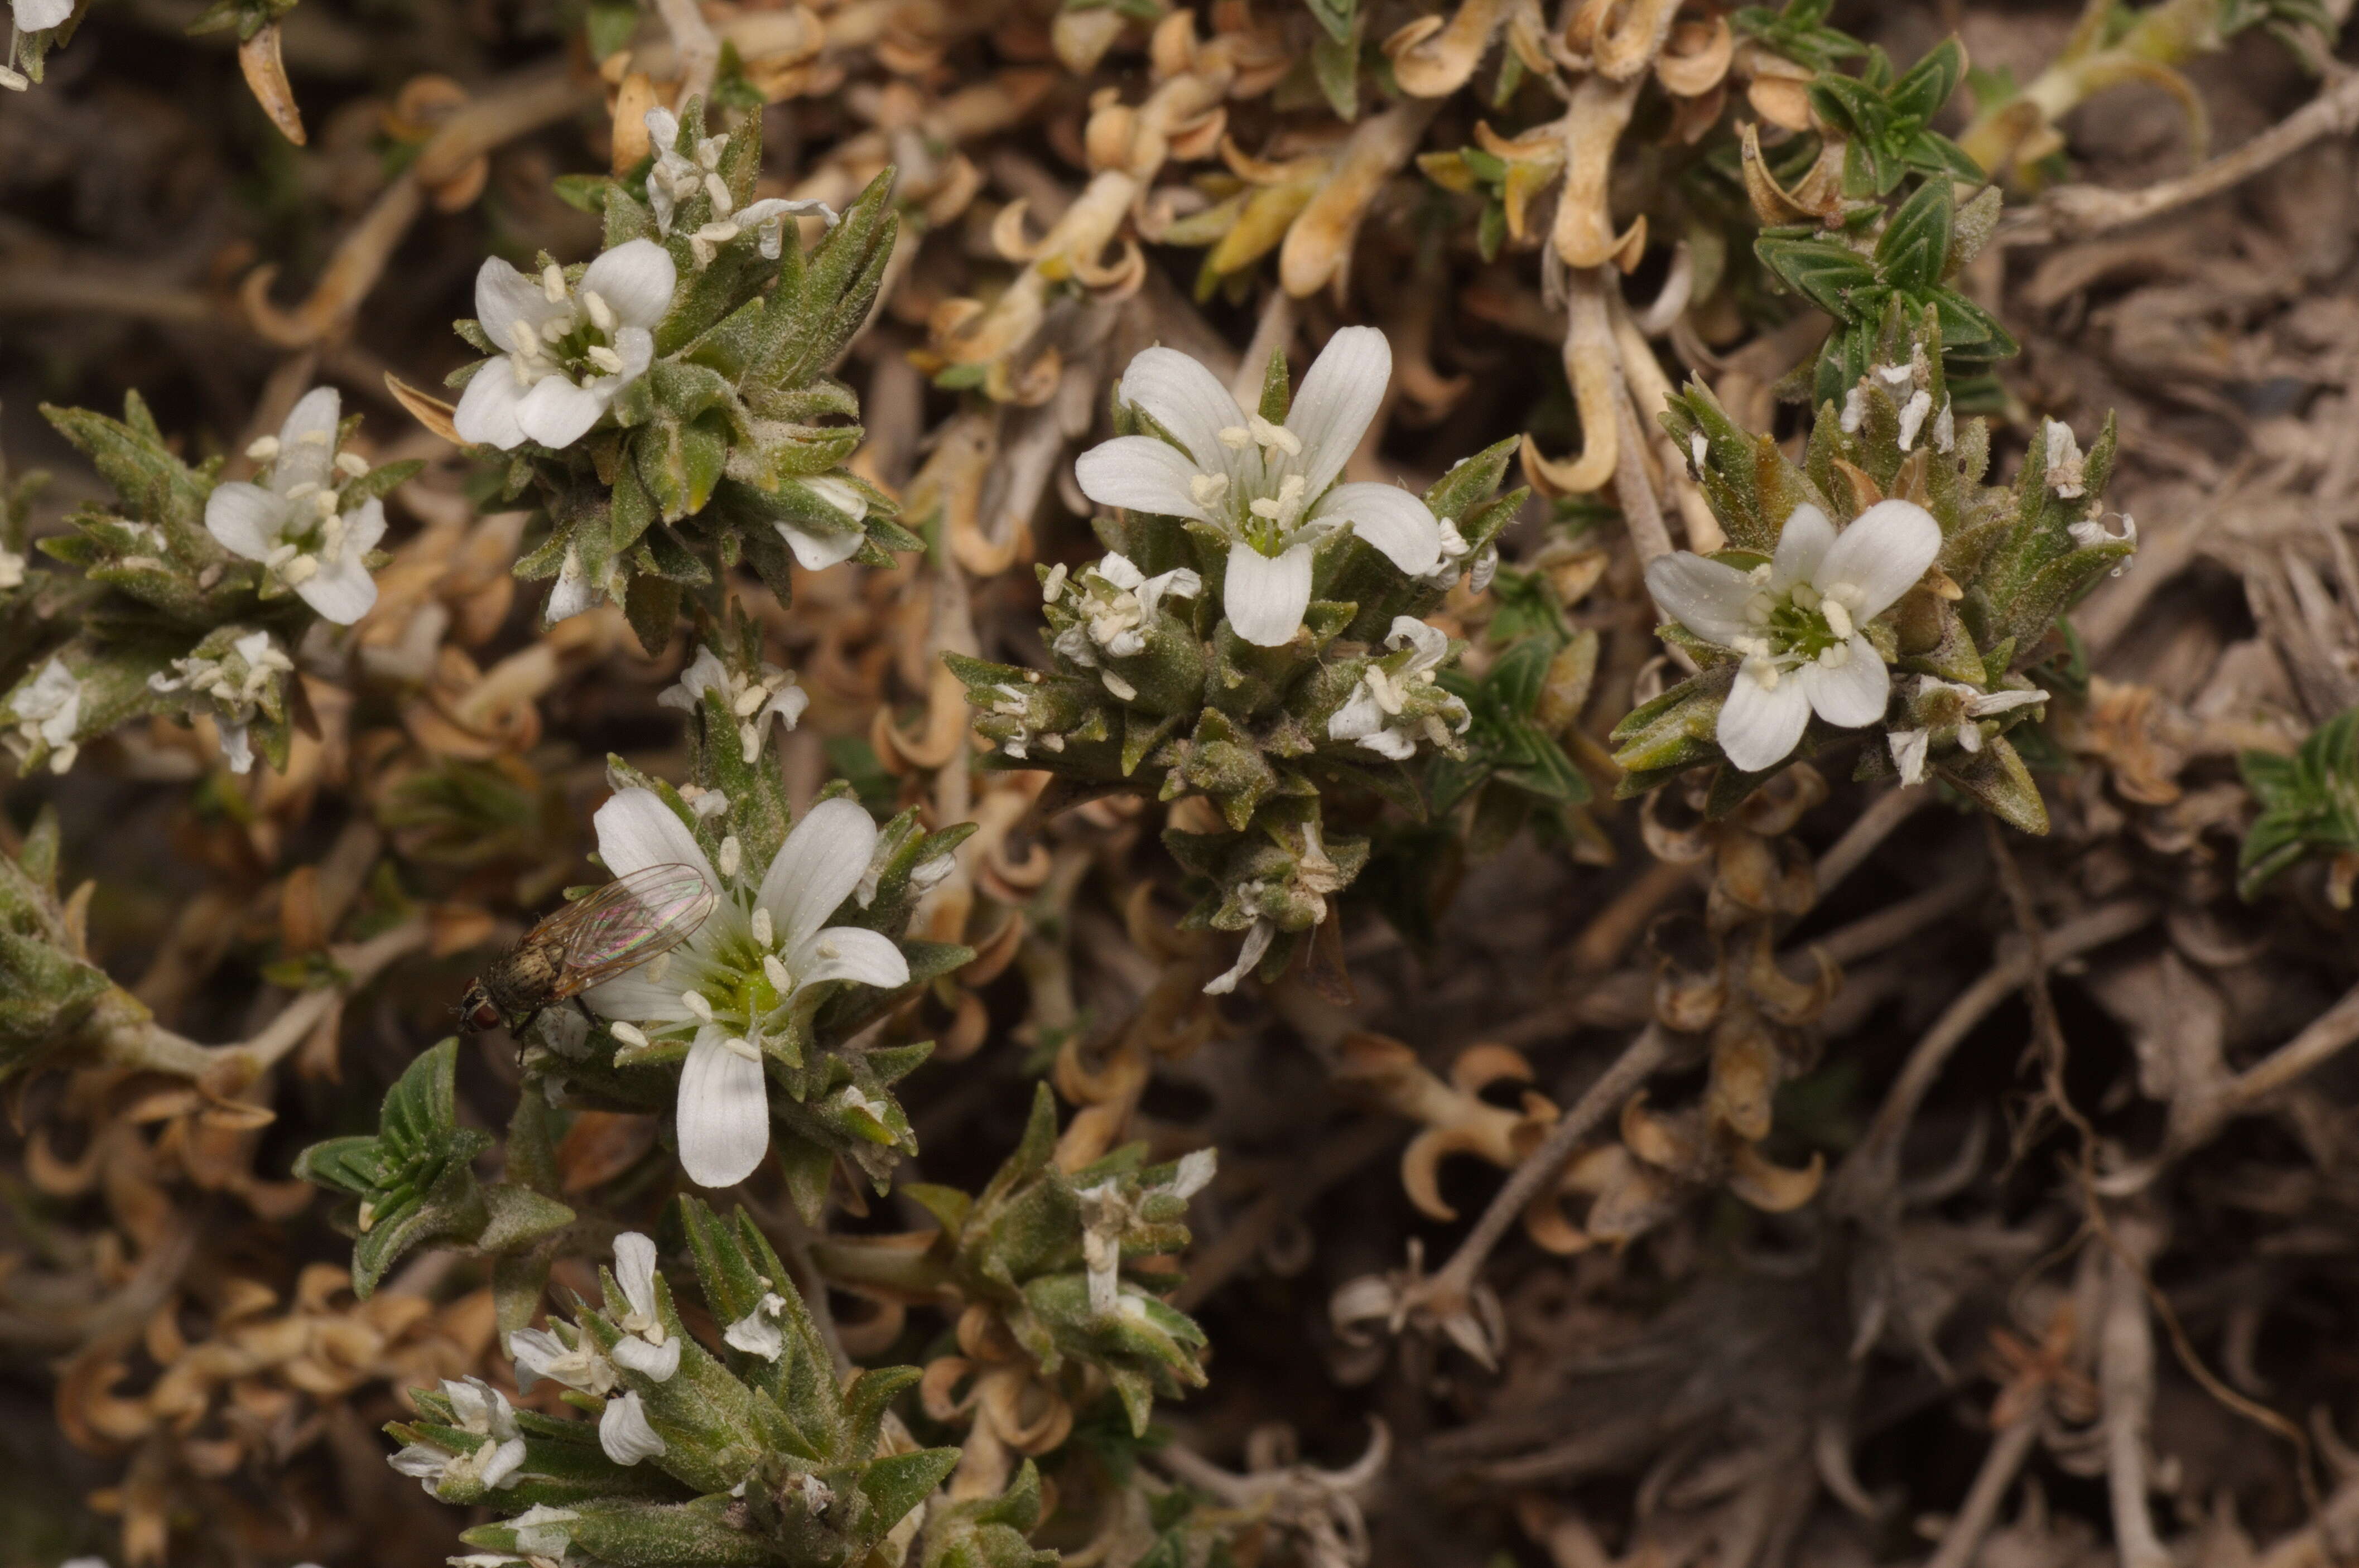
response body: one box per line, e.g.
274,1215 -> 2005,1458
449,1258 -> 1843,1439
1647,500 -> 1942,773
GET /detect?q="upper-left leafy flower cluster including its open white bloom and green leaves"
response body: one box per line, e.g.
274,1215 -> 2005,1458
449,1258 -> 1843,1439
434,102 -> 918,651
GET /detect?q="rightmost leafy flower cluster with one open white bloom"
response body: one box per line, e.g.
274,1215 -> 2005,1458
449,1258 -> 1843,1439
1614,298 -> 2137,832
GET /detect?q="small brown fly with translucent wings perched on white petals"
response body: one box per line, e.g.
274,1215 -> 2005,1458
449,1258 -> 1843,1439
458,865 -> 720,1042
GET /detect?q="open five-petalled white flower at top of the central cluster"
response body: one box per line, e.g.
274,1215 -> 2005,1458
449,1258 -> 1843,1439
1073,328 -> 1441,648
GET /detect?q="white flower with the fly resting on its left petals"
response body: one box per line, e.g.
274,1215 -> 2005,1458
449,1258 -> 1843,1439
585,790 -> 908,1186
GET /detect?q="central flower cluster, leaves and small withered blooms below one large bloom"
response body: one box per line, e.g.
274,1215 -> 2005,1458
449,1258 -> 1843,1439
951,328 -> 1522,990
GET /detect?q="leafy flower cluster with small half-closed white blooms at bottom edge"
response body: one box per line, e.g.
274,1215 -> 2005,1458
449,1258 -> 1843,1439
387,1198 -> 958,1568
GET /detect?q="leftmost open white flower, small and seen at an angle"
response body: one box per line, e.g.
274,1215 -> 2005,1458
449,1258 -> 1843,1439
205,387 -> 384,627
